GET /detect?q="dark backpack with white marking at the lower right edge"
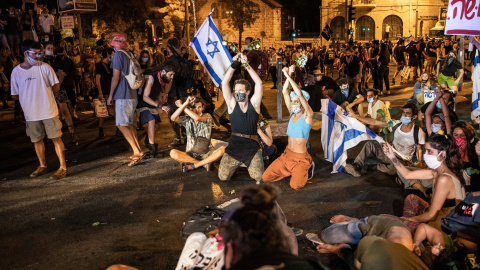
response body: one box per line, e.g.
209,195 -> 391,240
442,192 -> 480,240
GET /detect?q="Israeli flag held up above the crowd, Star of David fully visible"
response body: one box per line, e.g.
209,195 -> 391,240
190,13 -> 232,87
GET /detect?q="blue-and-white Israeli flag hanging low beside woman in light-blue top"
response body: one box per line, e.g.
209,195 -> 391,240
321,99 -> 384,173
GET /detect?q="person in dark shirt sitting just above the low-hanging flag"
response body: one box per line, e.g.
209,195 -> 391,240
332,79 -> 364,115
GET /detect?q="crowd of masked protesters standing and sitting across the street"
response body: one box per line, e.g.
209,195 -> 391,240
0,7 -> 480,269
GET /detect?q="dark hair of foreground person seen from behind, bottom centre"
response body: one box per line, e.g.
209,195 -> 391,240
220,184 -> 290,263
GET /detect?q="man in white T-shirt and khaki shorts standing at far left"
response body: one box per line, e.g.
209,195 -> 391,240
11,40 -> 67,179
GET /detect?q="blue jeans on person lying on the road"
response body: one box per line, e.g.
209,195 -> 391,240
322,217 -> 368,245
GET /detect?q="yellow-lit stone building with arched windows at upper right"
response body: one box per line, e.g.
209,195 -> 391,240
320,0 -> 448,41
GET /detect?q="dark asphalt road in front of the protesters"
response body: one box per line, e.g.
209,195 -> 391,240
0,70 -> 471,269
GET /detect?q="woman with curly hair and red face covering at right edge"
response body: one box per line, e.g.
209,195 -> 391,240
452,121 -> 480,191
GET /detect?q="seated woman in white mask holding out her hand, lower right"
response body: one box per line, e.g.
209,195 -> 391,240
383,134 -> 465,231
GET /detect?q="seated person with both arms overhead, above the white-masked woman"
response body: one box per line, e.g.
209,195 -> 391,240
425,88 -> 452,136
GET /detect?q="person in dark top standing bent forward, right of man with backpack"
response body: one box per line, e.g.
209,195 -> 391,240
137,61 -> 175,158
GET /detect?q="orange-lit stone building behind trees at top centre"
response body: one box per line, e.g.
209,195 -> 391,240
197,0 -> 283,48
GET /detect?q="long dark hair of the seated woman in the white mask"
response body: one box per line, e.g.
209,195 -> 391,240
427,134 -> 465,186
